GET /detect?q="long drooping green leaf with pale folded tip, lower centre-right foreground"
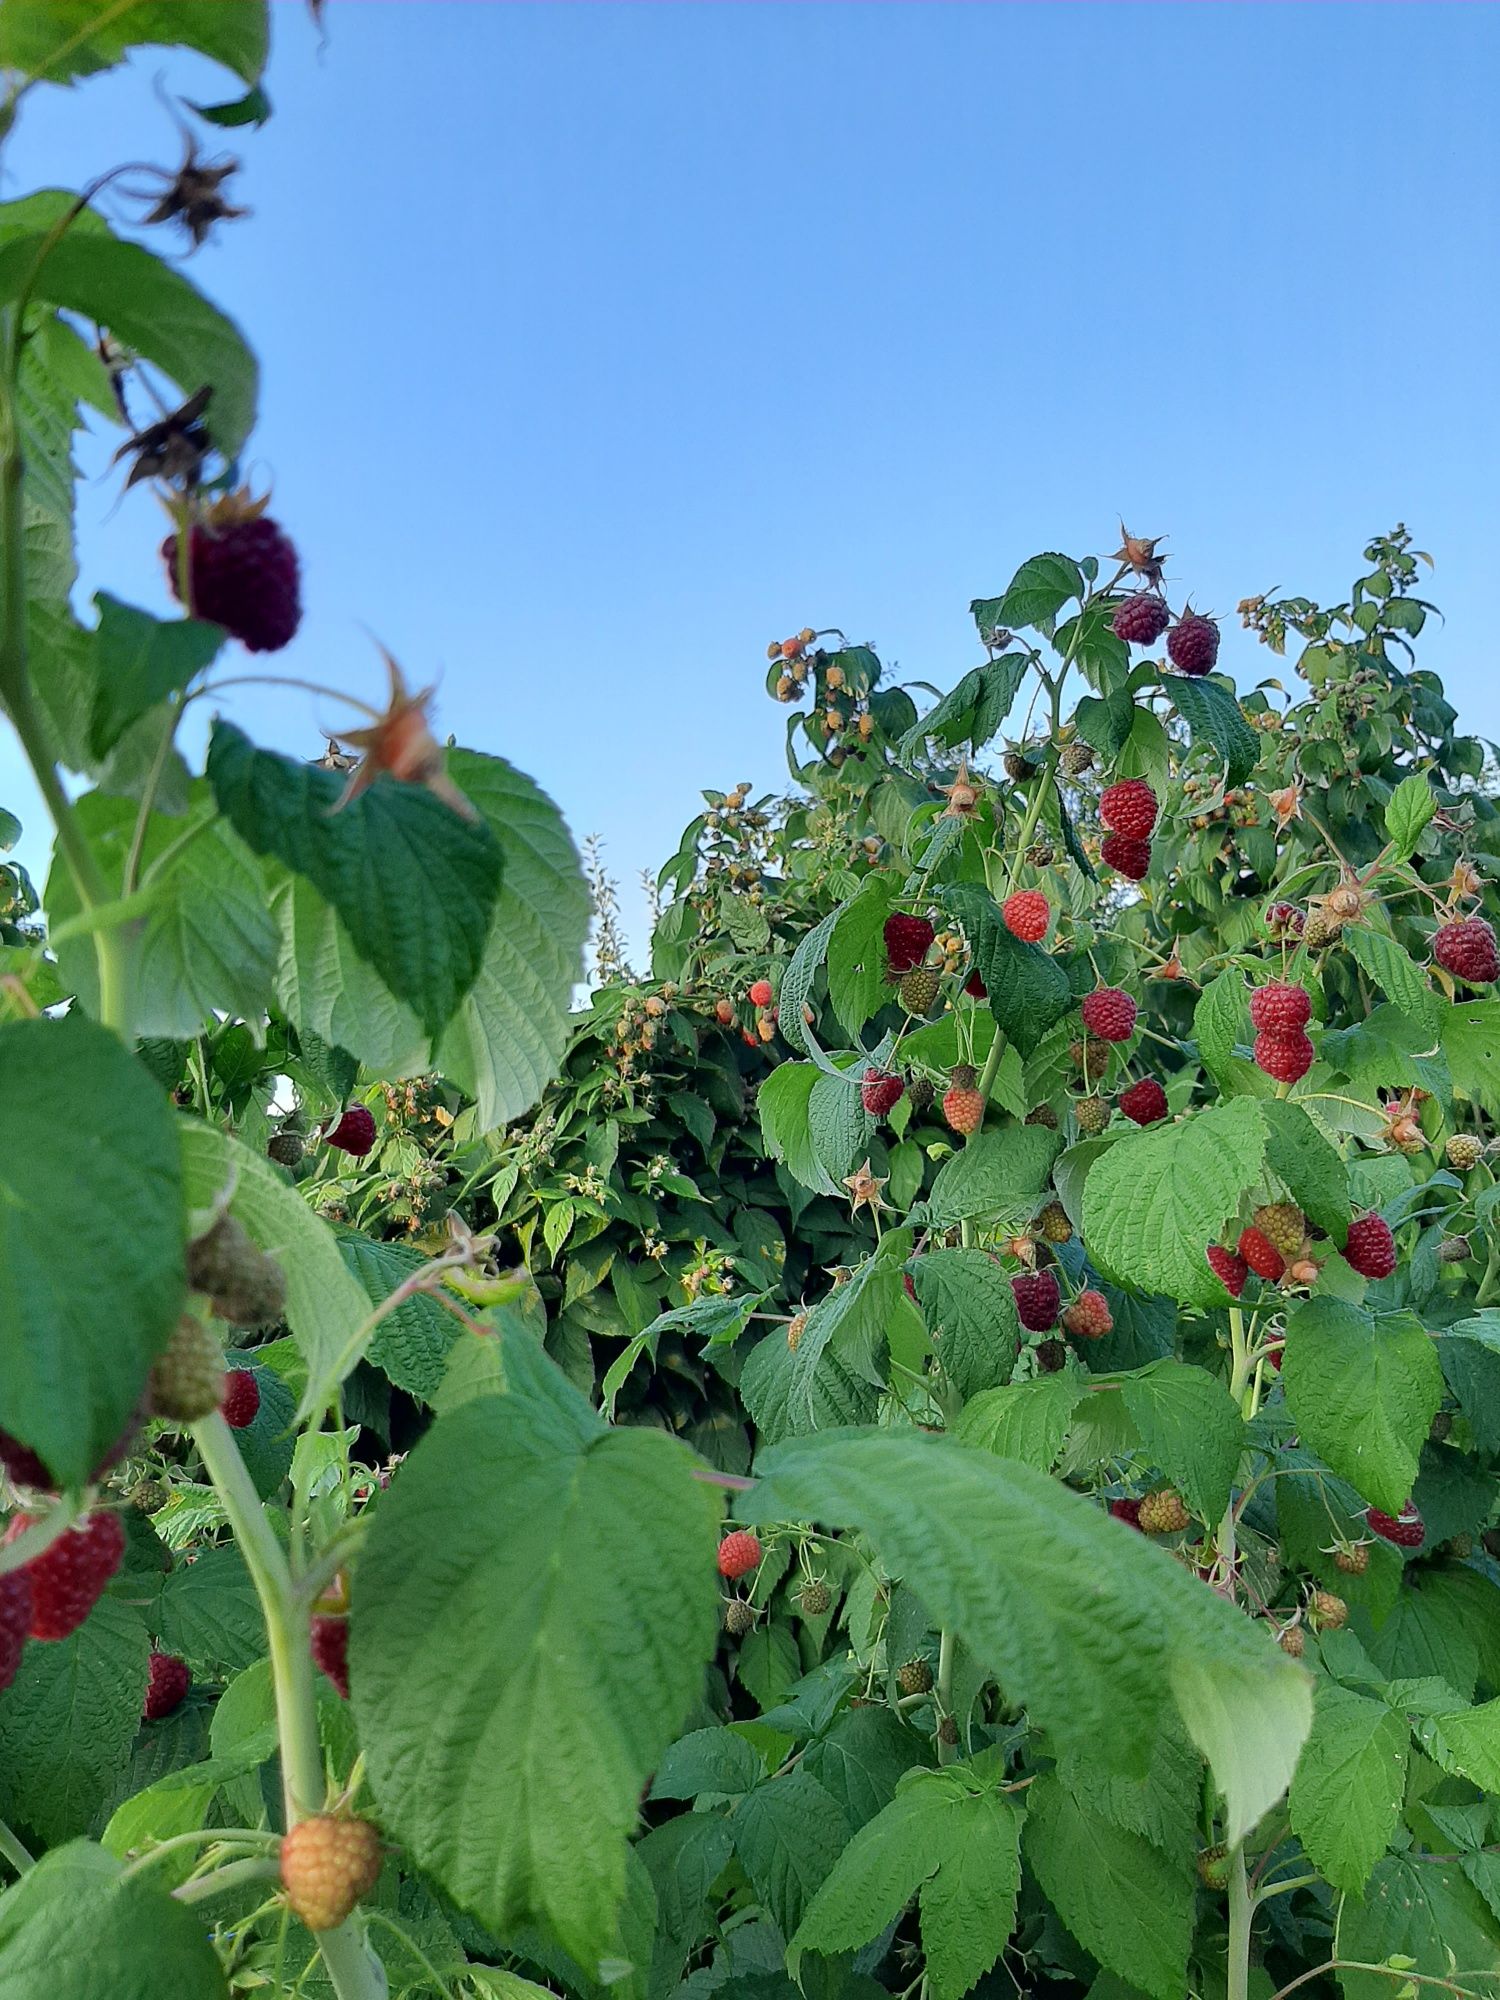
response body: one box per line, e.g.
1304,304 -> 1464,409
740,1432 -> 1312,1838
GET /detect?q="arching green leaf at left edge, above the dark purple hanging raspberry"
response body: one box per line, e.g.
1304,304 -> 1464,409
0,201 -> 258,458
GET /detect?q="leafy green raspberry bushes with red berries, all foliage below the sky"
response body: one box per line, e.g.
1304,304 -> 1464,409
0,15 -> 1500,2000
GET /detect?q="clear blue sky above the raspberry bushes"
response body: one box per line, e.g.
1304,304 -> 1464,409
0,0 -> 1500,944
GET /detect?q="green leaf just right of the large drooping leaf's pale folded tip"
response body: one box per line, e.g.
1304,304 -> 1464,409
1290,1680 -> 1408,1896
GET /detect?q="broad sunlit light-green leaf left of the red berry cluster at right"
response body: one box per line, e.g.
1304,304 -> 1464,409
1084,1098 -> 1266,1306
